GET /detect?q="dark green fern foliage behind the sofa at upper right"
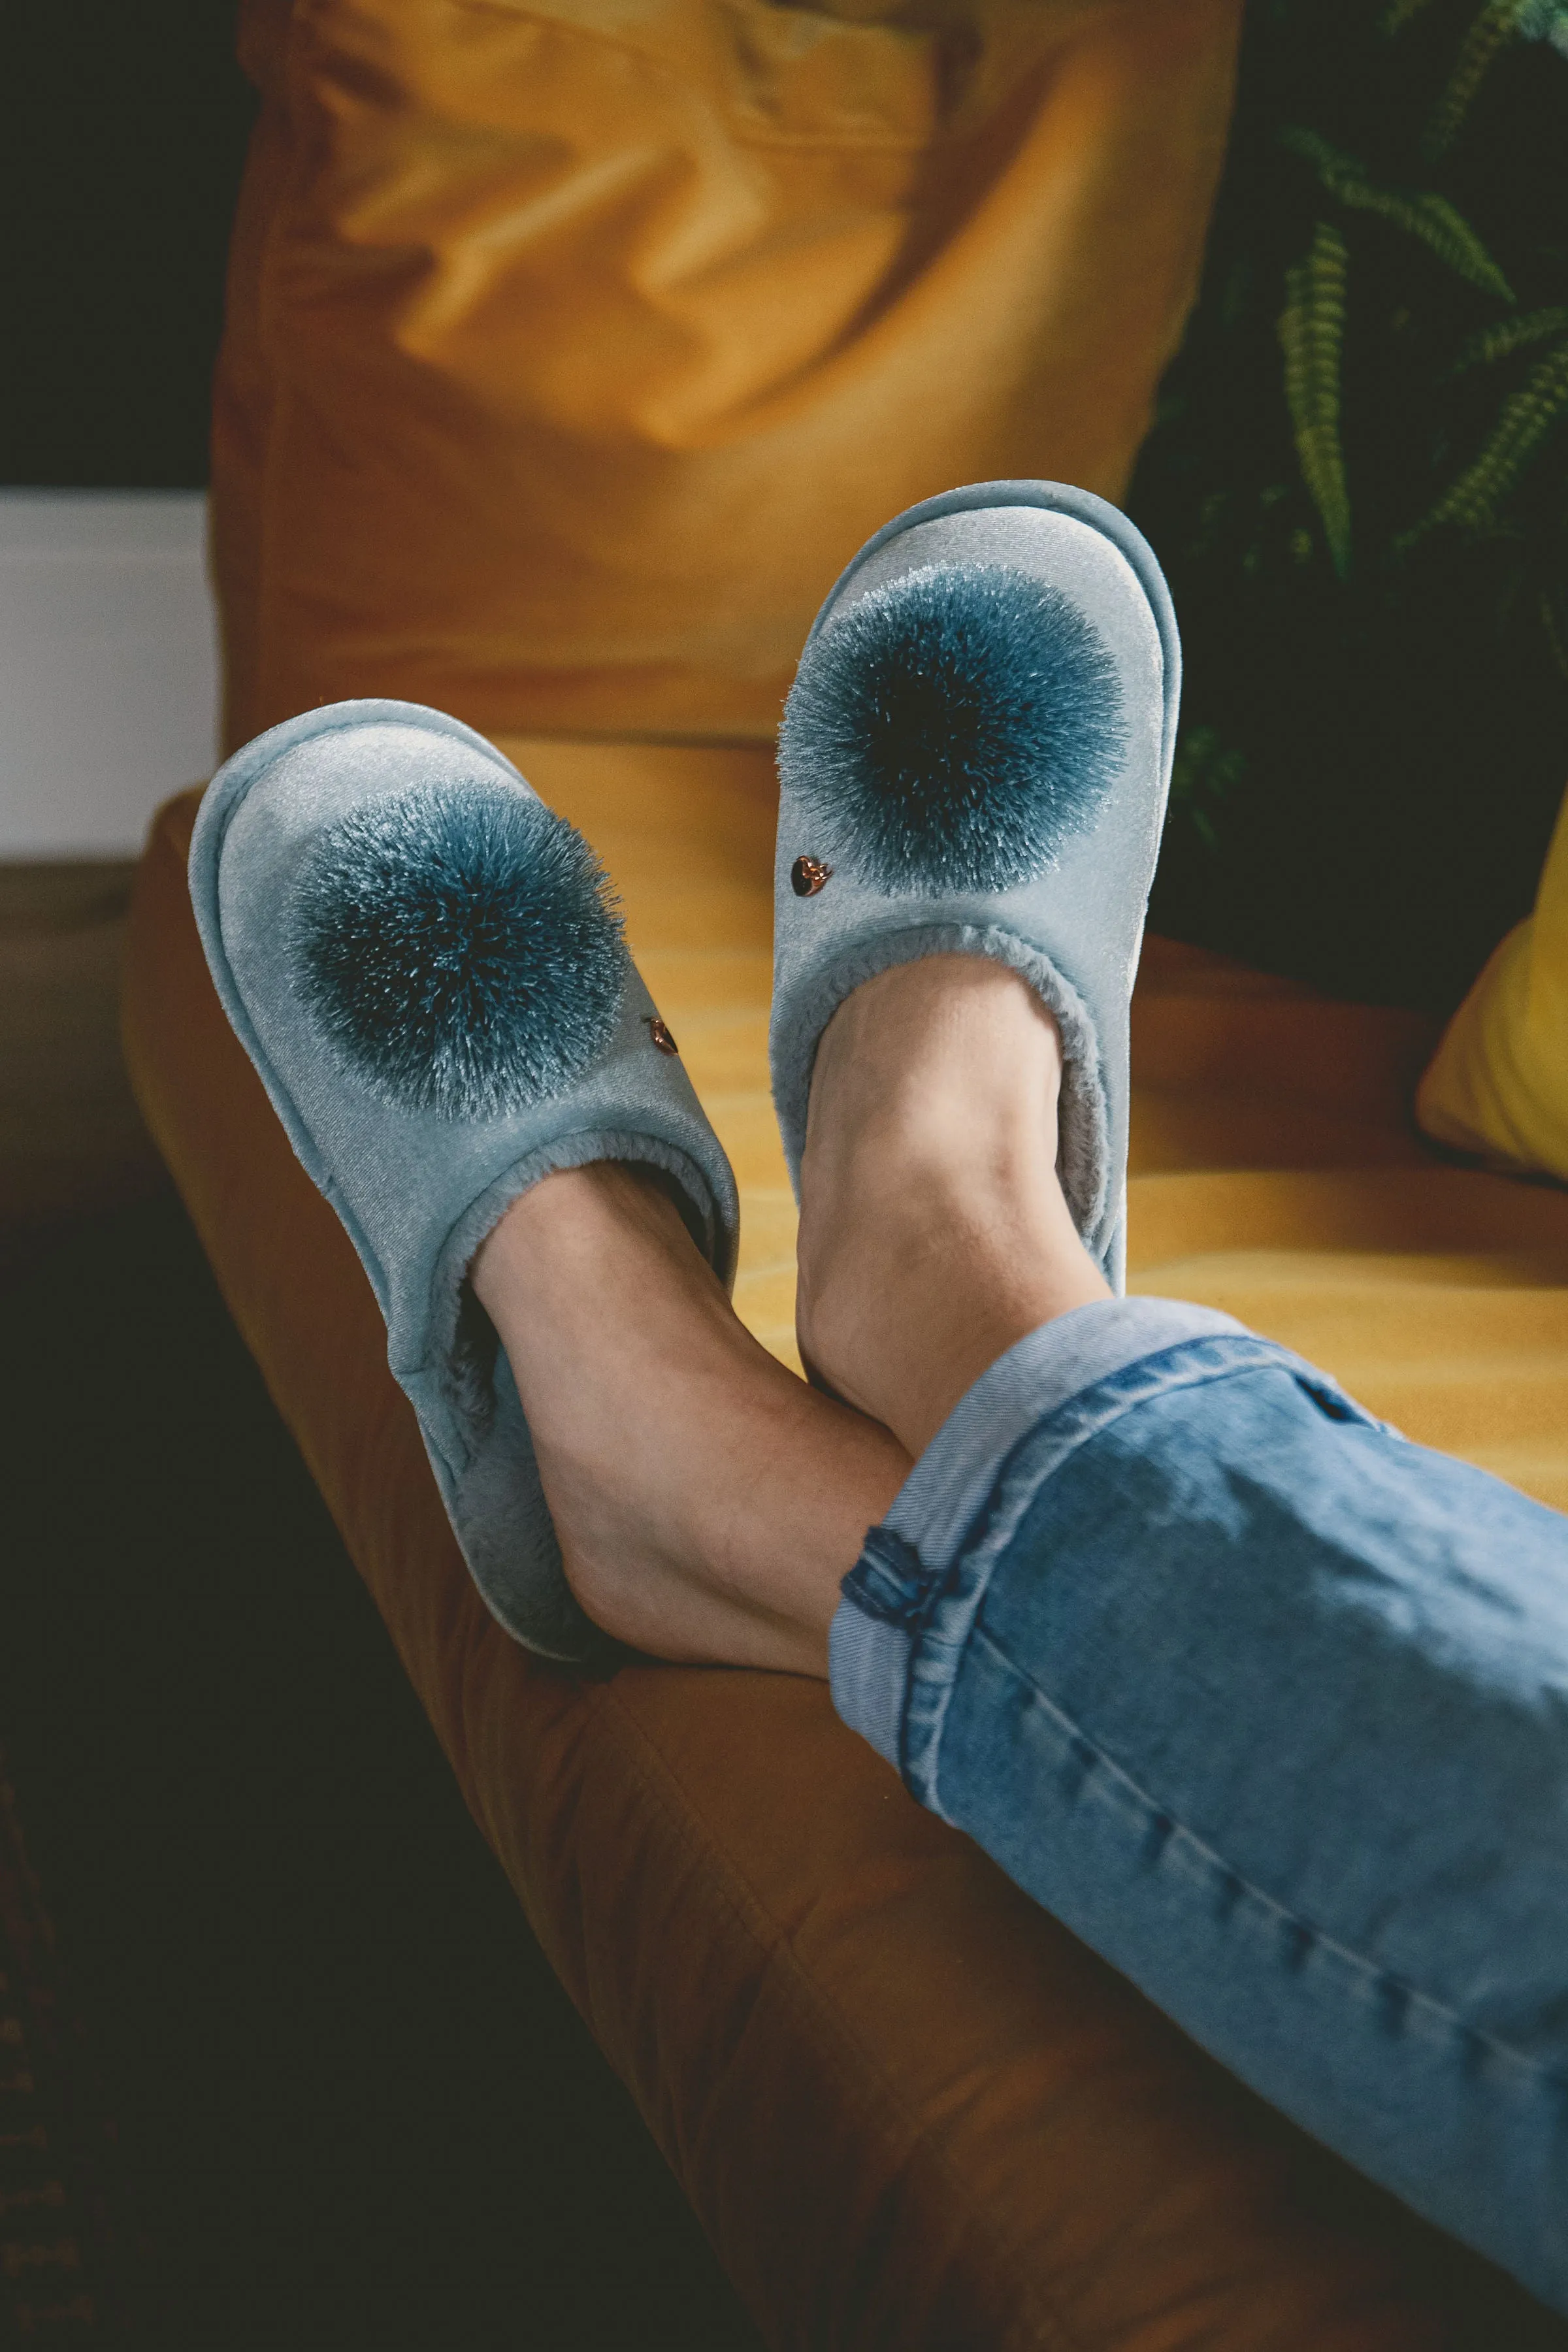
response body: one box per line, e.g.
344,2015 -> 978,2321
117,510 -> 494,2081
1133,0 -> 1568,1009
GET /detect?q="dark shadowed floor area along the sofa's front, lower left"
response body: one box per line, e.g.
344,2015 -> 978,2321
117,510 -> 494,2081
0,1195 -> 759,2352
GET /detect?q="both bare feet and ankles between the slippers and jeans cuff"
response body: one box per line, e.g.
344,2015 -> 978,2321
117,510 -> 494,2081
461,957 -> 1109,1674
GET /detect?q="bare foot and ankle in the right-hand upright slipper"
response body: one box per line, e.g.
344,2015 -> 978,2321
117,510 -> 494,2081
797,955 -> 1109,1454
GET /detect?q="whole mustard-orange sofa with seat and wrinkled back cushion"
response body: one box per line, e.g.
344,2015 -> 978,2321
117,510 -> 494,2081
125,0 -> 1568,2352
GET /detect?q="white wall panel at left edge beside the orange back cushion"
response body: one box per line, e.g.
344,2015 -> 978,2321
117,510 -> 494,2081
0,489 -> 219,858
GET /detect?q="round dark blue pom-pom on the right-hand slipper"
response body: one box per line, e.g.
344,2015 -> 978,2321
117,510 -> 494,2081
778,564 -> 1126,891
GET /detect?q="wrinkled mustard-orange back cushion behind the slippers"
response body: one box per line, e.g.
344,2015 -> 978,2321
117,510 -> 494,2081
214,0 -> 1239,745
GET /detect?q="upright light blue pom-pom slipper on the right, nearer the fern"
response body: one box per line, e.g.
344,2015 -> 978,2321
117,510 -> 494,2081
771,482 -> 1180,1291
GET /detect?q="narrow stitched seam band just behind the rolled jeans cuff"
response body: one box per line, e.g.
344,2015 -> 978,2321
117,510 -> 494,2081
902,1331 -> 1326,1820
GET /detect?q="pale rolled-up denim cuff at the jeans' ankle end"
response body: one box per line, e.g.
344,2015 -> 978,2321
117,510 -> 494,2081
828,1298 -> 1246,1767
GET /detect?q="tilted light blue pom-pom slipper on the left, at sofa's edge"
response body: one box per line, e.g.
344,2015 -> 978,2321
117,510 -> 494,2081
190,701 -> 738,1661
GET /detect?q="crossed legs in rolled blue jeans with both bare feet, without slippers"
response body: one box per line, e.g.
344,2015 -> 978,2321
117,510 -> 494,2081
475,926 -> 1568,2302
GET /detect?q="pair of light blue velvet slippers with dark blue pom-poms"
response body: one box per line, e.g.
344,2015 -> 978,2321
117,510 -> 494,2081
190,482 -> 1180,1661
